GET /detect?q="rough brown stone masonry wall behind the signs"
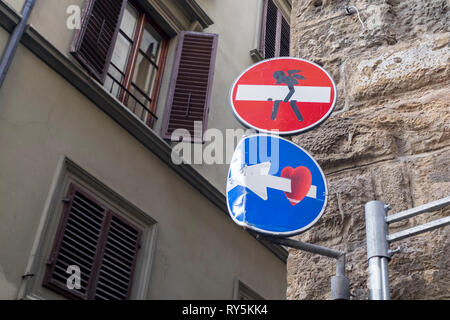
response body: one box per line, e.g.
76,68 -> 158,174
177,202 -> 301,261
287,0 -> 450,299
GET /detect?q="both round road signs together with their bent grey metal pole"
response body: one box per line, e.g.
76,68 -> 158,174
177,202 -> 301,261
227,57 -> 342,300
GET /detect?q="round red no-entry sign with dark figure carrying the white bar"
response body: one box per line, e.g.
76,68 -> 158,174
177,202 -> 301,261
230,57 -> 337,135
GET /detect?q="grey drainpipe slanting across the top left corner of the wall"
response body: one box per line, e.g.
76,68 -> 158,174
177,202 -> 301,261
0,0 -> 36,88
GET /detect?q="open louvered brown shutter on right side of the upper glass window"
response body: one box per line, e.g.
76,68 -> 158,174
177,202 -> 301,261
163,31 -> 218,141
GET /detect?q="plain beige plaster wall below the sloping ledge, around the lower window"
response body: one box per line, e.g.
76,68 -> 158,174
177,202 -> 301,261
0,29 -> 286,299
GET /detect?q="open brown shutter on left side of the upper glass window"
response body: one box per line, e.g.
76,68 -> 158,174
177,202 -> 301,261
71,0 -> 127,83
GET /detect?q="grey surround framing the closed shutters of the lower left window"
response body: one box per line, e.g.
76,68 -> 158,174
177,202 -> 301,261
17,156 -> 159,300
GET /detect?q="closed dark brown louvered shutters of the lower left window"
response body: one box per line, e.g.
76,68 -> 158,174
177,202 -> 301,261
44,184 -> 141,300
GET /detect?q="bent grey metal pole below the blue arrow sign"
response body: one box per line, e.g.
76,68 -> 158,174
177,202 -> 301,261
252,232 -> 350,300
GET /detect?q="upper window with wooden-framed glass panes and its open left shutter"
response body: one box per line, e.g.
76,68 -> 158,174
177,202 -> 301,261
72,0 -> 167,127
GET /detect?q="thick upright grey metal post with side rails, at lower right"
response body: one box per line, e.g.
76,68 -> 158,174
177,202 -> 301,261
365,200 -> 391,300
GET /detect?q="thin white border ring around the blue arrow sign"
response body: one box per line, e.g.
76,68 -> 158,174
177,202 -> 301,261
226,133 -> 328,237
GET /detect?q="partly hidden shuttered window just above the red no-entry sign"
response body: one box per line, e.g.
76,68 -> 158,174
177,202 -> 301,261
260,0 -> 290,59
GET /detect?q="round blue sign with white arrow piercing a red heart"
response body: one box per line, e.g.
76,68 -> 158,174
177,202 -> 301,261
227,134 -> 328,236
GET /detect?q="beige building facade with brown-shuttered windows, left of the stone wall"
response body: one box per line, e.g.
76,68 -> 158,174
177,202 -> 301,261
0,0 -> 291,299
